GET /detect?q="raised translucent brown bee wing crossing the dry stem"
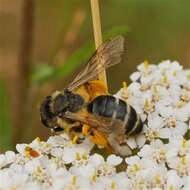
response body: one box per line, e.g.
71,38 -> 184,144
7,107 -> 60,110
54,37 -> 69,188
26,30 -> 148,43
68,36 -> 124,90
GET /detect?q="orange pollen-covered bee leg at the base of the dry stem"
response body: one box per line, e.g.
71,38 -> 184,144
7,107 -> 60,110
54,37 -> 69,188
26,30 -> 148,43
87,80 -> 108,99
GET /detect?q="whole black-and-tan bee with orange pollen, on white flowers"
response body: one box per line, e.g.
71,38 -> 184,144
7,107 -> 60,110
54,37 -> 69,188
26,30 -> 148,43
40,36 -> 143,155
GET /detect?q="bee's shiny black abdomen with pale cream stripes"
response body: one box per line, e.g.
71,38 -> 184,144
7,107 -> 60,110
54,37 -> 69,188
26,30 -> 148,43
88,95 -> 143,135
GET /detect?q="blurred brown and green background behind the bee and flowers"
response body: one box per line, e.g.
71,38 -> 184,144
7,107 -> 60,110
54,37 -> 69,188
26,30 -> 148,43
0,0 -> 190,152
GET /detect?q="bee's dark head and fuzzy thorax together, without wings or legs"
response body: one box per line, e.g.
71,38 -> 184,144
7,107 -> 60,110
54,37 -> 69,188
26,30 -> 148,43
40,89 -> 84,132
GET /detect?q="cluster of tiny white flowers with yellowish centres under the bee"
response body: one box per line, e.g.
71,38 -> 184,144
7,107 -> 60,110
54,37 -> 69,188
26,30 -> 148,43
0,61 -> 190,190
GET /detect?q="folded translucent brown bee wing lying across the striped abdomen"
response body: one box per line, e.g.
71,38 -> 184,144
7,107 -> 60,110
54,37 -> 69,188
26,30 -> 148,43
63,111 -> 123,133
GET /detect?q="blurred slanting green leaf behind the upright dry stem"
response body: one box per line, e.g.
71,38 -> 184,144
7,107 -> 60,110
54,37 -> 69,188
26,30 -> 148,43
32,25 -> 129,84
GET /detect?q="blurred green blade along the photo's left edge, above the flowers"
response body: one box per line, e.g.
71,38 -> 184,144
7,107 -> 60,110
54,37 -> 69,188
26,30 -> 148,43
0,80 -> 12,151
